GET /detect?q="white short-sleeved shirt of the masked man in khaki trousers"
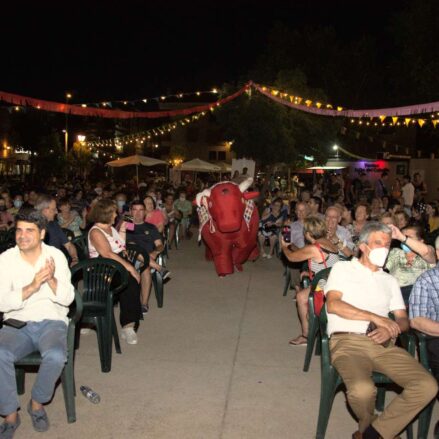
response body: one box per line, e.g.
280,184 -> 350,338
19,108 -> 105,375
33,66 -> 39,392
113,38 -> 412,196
324,258 -> 405,335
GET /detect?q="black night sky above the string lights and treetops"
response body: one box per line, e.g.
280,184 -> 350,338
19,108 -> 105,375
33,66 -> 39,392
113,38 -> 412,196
0,0 -> 406,102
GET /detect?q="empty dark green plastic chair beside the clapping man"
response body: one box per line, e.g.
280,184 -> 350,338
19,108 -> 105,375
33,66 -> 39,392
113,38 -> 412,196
71,257 -> 128,372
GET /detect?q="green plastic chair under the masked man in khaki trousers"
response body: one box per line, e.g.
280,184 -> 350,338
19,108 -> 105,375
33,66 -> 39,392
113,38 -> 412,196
316,305 -> 415,439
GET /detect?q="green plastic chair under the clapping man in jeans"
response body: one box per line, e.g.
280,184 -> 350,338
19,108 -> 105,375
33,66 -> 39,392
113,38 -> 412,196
15,289 -> 83,423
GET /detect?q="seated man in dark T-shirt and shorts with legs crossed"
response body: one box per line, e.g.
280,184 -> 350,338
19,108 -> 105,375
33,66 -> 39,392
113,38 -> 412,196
119,201 -> 171,314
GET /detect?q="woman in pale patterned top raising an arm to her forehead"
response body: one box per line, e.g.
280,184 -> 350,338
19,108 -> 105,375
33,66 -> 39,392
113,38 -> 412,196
385,225 -> 436,305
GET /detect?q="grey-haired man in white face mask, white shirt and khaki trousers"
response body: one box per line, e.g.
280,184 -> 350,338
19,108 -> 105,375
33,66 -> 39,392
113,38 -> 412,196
325,222 -> 437,439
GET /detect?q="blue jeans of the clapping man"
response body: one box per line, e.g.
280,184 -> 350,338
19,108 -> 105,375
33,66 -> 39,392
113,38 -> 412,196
0,320 -> 67,416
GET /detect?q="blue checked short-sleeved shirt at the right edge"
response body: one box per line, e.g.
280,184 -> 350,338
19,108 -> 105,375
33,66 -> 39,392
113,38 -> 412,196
409,264 -> 439,322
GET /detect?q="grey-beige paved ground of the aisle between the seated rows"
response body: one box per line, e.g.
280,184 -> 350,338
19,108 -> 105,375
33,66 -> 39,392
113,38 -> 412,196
12,239 -> 437,439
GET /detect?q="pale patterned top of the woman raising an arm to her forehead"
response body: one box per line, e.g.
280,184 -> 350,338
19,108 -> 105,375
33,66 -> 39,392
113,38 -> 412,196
385,248 -> 434,287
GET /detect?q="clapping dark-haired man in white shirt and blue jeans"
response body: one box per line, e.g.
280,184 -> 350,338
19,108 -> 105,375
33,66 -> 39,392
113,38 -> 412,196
0,210 -> 74,439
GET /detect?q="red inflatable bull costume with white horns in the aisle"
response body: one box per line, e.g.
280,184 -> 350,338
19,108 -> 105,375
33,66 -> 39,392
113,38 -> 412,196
195,178 -> 259,276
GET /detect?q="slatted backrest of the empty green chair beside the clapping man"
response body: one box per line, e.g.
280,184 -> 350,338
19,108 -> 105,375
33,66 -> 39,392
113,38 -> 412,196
71,258 -> 128,303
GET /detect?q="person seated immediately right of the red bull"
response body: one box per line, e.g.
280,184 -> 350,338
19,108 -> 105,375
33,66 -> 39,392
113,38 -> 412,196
258,197 -> 288,259
